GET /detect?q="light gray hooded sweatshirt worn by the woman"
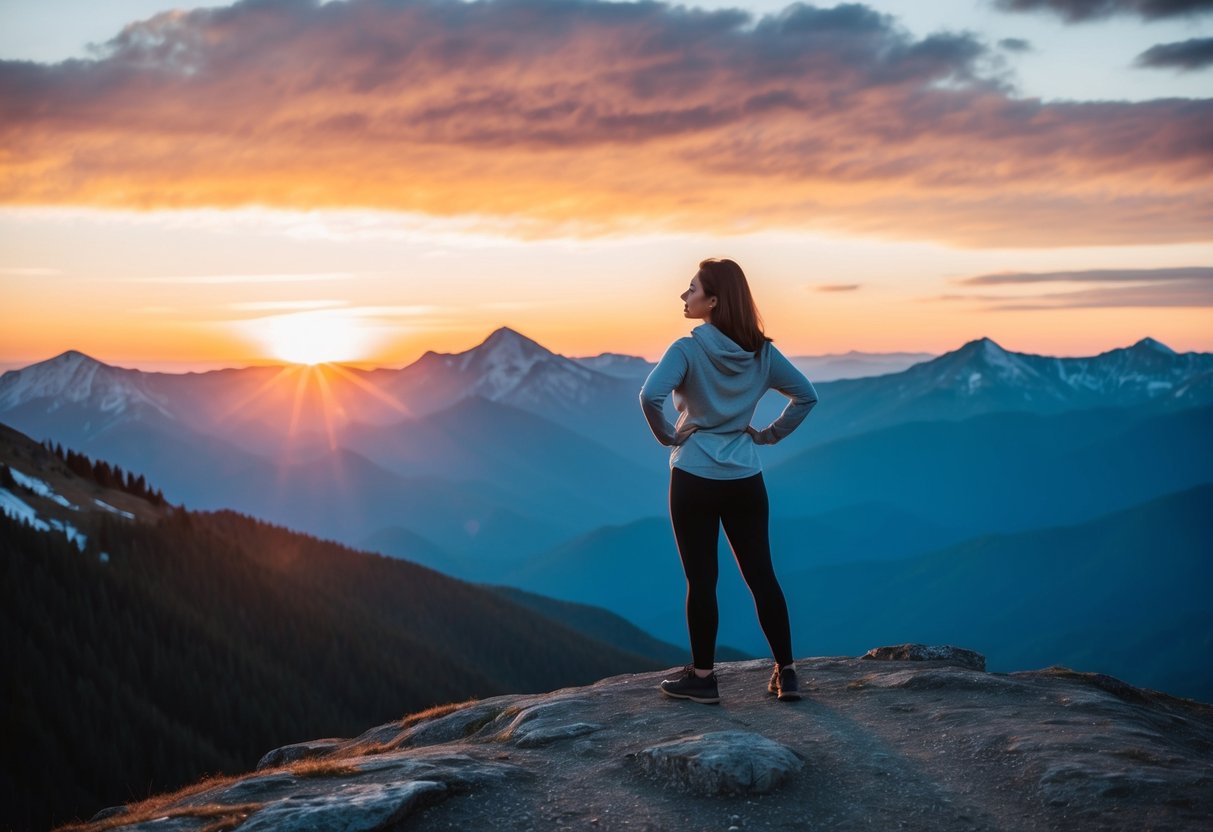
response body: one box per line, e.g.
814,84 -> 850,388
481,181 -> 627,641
640,324 -> 818,479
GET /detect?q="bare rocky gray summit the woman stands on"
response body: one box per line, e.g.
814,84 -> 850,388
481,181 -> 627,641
66,645 -> 1213,832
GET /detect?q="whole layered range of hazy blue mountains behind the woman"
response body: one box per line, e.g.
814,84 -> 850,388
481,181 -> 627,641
0,329 -> 1213,688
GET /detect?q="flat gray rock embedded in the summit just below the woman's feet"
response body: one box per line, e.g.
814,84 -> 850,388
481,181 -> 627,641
639,731 -> 804,794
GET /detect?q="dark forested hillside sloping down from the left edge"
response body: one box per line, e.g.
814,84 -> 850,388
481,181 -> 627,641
0,448 -> 668,830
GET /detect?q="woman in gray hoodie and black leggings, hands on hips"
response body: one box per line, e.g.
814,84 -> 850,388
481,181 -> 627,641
640,260 -> 818,703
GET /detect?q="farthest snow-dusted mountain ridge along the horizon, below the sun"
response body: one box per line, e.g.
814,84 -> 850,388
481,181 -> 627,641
0,327 -> 1213,461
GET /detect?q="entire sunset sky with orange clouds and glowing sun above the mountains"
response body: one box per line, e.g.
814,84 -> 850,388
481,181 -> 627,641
0,0 -> 1213,371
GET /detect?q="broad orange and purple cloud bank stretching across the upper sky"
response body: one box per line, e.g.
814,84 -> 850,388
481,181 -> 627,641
0,0 -> 1213,246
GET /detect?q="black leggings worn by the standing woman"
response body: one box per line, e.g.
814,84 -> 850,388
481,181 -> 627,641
670,468 -> 792,671
